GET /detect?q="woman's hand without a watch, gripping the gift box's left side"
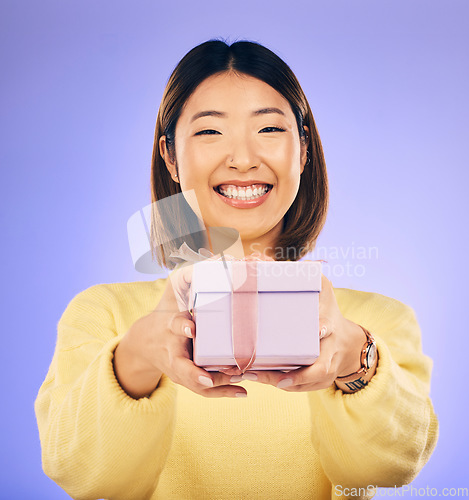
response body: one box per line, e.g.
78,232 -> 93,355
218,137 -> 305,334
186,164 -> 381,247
116,266 -> 247,398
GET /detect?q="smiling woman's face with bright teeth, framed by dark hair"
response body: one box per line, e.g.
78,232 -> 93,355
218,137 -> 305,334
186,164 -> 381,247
160,72 -> 308,253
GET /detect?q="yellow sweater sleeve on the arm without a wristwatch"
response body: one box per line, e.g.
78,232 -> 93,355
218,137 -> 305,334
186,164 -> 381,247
35,285 -> 176,500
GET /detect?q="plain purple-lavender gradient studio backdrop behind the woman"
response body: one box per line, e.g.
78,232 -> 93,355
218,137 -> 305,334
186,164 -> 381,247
0,0 -> 469,500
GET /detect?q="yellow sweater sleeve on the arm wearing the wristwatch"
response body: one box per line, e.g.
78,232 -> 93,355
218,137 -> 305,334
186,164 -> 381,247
308,292 -> 438,488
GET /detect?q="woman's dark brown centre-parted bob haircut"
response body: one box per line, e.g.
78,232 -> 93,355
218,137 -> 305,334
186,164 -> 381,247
150,40 -> 329,269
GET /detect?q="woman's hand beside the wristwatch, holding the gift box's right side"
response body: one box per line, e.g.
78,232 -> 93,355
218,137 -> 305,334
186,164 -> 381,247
229,275 -> 366,392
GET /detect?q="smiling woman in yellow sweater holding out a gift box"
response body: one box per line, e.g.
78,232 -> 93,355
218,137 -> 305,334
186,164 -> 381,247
35,41 -> 438,500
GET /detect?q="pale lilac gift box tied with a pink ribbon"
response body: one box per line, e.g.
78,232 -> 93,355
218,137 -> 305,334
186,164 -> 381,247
189,259 -> 321,372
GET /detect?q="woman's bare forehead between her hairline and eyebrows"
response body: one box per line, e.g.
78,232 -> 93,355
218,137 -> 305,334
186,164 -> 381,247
181,72 -> 293,118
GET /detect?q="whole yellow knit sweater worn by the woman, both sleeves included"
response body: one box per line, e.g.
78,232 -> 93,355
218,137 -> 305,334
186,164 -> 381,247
35,280 -> 438,500
